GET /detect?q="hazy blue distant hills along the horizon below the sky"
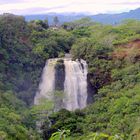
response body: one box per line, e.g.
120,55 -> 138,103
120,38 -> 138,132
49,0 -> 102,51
25,8 -> 140,25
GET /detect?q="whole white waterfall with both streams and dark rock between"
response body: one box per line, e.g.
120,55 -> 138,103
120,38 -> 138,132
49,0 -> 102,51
34,58 -> 88,110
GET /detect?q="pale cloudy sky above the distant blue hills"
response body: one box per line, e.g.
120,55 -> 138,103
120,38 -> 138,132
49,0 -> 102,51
0,0 -> 140,15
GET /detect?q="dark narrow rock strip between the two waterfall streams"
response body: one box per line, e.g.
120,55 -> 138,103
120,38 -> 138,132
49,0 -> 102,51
55,59 -> 65,90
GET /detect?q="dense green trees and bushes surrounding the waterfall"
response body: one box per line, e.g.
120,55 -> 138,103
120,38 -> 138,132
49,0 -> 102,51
0,14 -> 140,140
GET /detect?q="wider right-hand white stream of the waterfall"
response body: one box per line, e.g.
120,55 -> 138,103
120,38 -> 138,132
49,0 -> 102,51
63,60 -> 87,110
